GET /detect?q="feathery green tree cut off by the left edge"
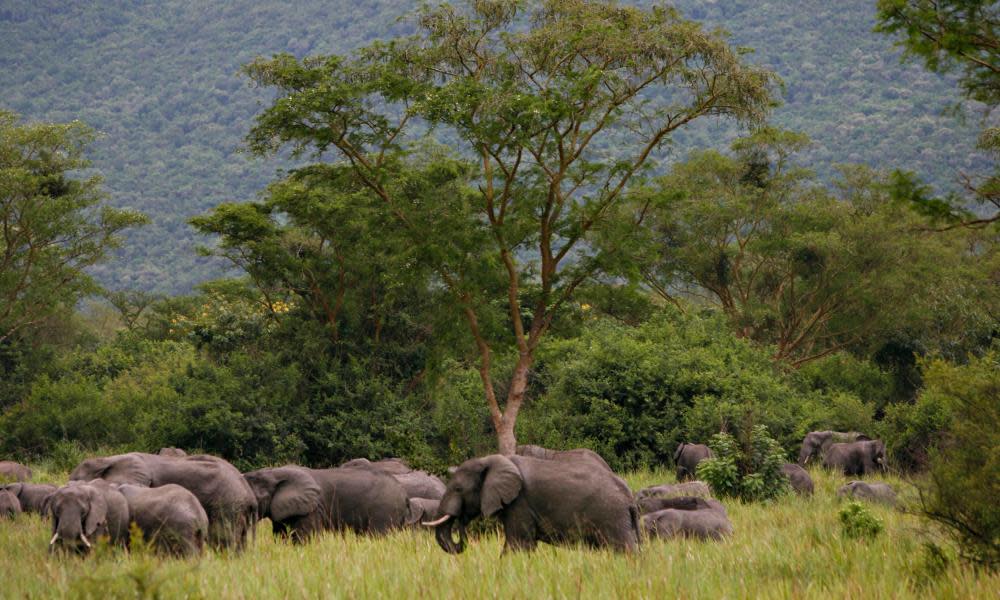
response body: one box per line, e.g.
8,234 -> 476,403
0,111 -> 145,343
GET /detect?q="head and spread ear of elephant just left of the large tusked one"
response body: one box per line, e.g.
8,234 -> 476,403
243,466 -> 322,522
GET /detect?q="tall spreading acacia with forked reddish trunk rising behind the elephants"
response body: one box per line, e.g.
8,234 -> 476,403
246,0 -> 774,454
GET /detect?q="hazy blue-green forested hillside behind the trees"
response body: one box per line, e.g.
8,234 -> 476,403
0,0 -> 977,293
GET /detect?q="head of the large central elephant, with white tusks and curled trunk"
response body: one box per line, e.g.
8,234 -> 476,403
424,454 -> 524,554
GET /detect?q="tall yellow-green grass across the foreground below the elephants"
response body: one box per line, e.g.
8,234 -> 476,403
0,471 -> 1000,599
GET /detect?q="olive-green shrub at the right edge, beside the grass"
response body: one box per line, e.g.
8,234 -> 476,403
921,348 -> 1000,569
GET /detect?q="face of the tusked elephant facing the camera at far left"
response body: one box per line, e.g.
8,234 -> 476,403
45,482 -> 108,552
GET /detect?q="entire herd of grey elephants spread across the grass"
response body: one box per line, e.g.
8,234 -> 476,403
0,431 -> 895,555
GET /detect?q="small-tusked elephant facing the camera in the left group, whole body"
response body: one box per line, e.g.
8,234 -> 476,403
44,479 -> 129,553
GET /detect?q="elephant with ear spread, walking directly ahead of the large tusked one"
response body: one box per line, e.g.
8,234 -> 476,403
243,465 -> 409,542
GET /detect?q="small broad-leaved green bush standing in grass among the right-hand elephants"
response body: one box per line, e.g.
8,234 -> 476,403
698,425 -> 788,502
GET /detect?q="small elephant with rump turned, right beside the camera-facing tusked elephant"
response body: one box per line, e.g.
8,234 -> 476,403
115,483 -> 208,556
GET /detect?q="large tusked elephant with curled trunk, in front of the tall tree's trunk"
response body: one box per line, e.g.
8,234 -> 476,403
424,454 -> 639,554
